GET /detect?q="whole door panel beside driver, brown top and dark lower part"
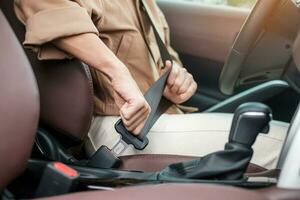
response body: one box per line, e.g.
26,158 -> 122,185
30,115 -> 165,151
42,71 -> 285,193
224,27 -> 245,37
157,0 -> 250,111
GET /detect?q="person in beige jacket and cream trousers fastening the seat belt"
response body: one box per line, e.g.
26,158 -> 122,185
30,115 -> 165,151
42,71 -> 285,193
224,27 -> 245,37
15,0 -> 287,168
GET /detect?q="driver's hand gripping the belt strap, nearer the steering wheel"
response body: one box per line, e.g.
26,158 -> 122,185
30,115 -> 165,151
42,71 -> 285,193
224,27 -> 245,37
164,61 -> 197,104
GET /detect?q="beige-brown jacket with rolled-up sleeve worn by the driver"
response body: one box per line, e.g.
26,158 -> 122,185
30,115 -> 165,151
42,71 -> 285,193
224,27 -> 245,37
15,0 -> 188,115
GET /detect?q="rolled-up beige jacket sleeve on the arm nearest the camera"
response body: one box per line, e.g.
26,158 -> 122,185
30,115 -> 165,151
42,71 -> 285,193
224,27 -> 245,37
15,0 -> 101,59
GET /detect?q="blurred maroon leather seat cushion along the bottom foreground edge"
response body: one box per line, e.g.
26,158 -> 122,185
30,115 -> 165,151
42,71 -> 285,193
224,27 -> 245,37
37,184 -> 267,200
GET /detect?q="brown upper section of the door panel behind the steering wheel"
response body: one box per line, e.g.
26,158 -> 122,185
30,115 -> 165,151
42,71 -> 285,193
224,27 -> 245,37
157,0 -> 249,62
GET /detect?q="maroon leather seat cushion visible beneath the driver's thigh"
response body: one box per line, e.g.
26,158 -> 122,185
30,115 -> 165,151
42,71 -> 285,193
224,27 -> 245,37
119,154 -> 266,173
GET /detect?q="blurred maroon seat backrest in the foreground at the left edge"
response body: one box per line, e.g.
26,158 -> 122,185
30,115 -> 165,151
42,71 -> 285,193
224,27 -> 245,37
0,10 -> 40,190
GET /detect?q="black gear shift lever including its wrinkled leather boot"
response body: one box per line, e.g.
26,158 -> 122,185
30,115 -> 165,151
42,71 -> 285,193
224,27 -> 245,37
158,103 -> 272,181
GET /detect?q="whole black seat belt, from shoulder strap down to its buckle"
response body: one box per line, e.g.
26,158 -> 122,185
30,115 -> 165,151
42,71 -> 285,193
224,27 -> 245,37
87,0 -> 172,168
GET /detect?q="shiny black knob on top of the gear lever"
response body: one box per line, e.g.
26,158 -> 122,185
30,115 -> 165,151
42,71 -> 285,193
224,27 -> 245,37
229,103 -> 272,147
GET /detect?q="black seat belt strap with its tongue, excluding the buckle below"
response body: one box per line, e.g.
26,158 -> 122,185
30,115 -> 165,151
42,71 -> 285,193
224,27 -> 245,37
115,0 -> 172,150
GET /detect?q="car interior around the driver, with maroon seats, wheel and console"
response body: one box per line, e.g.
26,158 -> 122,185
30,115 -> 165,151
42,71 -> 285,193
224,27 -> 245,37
0,0 -> 300,200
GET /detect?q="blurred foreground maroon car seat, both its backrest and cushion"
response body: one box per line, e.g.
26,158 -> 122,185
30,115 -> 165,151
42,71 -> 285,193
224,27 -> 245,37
0,7 -> 299,200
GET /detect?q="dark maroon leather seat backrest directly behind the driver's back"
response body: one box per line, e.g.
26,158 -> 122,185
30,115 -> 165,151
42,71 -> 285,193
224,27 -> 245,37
0,0 -> 93,141
